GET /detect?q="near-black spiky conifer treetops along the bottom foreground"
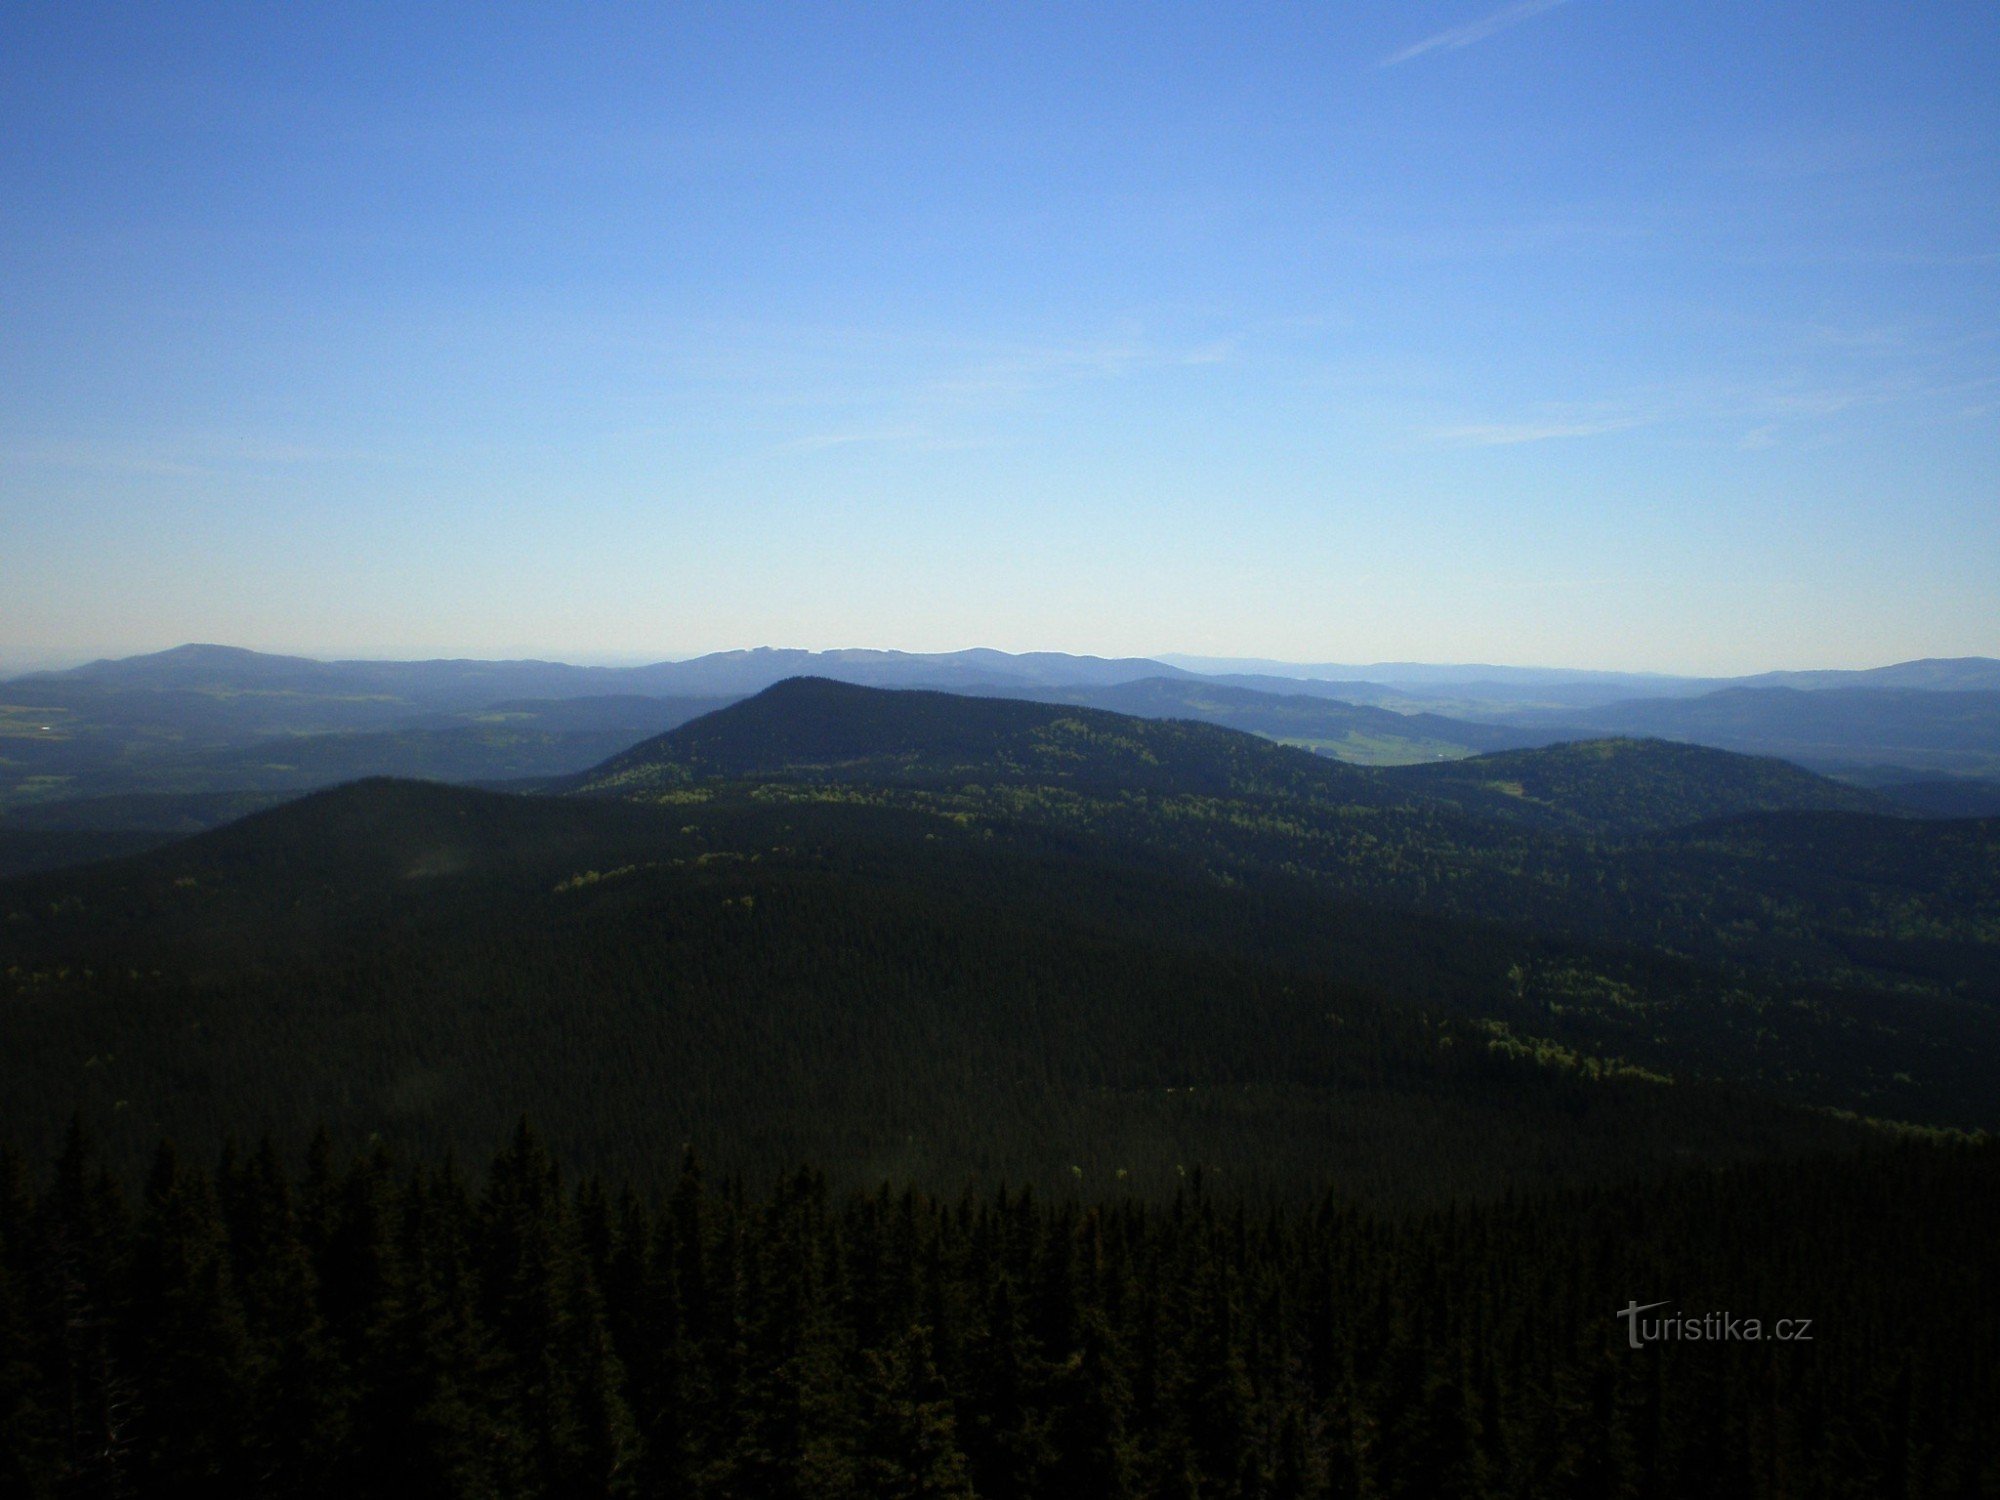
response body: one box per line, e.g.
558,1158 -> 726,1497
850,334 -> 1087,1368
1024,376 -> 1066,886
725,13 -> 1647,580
0,1124 -> 2000,1500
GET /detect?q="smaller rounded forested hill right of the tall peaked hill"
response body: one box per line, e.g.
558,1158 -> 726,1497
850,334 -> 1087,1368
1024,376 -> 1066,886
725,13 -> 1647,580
1376,740 -> 1902,836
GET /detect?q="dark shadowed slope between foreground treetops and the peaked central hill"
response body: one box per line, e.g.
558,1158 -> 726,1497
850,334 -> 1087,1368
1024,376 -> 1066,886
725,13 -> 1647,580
0,782 -> 1918,1200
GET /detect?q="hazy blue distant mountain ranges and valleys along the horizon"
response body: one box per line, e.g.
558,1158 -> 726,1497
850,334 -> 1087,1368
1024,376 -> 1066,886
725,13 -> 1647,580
0,646 -> 2000,830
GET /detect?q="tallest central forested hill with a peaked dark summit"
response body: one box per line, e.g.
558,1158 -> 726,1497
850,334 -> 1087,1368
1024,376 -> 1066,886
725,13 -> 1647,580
564,678 -> 1376,802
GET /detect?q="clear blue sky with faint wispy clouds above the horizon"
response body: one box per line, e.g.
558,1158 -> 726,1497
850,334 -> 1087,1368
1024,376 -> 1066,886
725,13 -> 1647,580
0,0 -> 2000,672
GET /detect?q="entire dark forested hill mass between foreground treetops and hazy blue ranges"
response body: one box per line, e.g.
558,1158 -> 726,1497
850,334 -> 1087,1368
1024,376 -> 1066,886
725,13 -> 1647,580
0,680 -> 2000,1198
